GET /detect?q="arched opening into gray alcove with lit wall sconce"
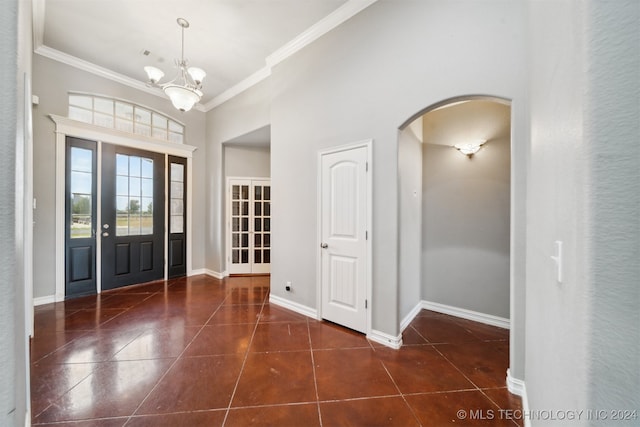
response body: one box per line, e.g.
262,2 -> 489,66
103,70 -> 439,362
398,95 -> 512,348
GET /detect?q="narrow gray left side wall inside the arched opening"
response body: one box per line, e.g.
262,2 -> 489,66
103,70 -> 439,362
398,124 -> 422,320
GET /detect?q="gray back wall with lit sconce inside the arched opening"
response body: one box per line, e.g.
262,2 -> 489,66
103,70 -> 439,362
422,100 -> 511,319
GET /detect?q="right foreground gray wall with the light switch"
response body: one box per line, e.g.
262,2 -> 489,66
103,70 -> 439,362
526,0 -> 640,426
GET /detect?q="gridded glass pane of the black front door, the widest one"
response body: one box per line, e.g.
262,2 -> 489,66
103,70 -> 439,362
115,154 -> 153,236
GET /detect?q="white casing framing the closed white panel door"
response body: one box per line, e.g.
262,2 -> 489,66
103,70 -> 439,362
316,139 -> 375,336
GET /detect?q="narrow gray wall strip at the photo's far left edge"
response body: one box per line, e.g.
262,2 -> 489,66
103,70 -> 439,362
0,0 -> 32,427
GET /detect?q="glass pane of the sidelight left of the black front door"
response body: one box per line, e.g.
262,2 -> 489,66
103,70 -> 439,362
69,147 -> 93,239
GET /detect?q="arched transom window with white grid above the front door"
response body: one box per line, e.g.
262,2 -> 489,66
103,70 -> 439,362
69,94 -> 184,144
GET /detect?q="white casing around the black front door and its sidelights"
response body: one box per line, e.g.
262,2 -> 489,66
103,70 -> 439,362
49,114 -> 197,302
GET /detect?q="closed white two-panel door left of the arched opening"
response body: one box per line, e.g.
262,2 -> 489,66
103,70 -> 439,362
320,146 -> 369,332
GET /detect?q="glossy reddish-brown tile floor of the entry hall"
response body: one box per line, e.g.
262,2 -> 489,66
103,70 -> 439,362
31,276 -> 521,427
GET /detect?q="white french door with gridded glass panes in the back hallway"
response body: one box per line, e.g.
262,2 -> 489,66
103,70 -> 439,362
227,178 -> 271,274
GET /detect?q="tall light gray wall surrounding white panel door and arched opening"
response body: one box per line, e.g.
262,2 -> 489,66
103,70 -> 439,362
271,0 -> 526,344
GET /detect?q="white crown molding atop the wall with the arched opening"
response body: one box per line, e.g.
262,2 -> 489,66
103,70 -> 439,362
266,0 -> 378,67
